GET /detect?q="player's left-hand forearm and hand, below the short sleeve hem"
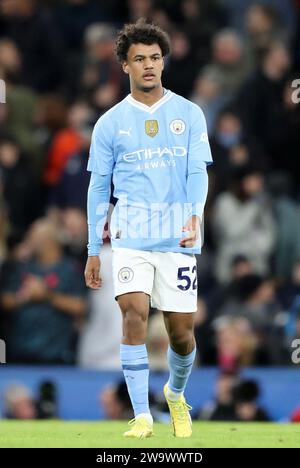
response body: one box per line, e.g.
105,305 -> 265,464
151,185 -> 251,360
84,172 -> 111,289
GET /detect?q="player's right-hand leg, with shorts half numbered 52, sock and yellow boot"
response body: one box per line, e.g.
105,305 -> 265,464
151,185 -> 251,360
152,253 -> 197,437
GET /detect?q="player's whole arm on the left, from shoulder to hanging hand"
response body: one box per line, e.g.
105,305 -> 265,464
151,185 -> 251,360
84,116 -> 114,289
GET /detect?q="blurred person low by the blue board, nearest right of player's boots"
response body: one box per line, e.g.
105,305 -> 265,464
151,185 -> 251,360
198,371 -> 238,421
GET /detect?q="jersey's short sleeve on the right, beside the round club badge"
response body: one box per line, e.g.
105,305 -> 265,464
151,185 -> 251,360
188,104 -> 213,174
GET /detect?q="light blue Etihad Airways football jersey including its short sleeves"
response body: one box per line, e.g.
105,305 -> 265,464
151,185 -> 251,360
88,90 -> 212,253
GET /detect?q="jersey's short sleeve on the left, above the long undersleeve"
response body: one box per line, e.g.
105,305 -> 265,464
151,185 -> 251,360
87,116 -> 114,175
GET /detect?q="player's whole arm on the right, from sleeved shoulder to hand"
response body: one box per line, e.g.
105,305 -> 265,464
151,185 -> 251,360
180,105 -> 212,247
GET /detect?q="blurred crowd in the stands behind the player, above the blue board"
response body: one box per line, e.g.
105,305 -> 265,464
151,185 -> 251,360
0,0 -> 300,372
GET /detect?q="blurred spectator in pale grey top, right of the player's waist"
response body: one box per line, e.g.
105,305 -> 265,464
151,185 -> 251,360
212,166 -> 275,283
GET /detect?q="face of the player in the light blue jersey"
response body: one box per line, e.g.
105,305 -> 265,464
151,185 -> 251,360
123,44 -> 164,92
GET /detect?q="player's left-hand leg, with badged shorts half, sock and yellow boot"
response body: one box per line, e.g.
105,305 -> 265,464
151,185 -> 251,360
113,249 -> 153,438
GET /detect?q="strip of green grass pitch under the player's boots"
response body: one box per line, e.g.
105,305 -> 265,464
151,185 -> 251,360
0,421 -> 300,448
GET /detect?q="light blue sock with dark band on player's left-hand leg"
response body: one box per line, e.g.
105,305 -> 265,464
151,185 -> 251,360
120,344 -> 150,417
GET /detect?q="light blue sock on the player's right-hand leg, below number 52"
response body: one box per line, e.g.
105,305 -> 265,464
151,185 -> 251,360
168,346 -> 196,393
